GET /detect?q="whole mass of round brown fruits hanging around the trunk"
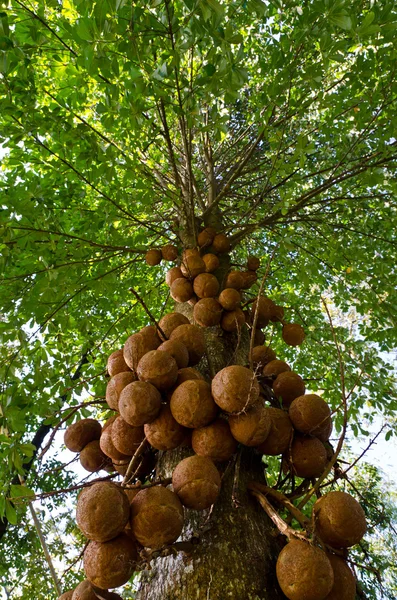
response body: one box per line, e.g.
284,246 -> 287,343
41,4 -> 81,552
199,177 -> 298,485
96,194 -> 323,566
58,228 -> 365,600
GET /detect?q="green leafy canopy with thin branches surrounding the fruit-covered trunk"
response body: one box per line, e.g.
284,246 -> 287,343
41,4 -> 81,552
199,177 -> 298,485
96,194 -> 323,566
0,0 -> 397,599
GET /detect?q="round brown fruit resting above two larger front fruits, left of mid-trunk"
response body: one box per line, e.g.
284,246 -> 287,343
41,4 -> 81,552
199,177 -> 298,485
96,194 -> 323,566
136,350 -> 178,391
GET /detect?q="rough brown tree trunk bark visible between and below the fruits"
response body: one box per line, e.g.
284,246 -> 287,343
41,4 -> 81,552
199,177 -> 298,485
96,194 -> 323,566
137,322 -> 285,600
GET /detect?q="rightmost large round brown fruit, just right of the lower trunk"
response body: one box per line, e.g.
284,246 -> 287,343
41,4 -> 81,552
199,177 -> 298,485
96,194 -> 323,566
313,492 -> 367,548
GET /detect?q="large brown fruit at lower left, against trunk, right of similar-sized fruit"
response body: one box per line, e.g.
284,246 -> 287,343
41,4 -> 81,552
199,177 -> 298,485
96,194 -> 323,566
131,486 -> 183,549
